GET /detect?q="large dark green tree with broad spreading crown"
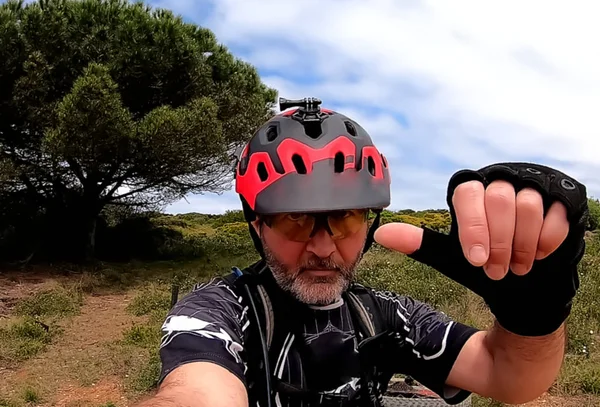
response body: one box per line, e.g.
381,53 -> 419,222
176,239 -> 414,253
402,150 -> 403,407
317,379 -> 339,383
0,0 -> 276,257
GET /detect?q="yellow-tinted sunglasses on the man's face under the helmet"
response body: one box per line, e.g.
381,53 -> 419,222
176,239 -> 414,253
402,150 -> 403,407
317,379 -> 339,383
262,209 -> 369,242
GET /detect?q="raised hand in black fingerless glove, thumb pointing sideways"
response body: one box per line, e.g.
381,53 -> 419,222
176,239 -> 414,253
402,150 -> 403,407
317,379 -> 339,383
374,163 -> 588,336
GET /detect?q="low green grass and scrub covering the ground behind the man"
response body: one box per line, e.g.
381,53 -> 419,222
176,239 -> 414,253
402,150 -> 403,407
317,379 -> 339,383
0,207 -> 600,407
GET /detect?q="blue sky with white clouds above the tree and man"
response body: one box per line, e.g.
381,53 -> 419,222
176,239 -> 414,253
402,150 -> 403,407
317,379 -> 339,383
5,0 -> 600,213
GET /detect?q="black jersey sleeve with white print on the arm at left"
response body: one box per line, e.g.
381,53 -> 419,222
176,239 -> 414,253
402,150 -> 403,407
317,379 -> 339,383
159,278 -> 249,384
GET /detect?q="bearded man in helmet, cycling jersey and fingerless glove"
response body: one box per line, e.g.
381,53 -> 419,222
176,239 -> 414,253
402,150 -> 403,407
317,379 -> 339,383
143,99 -> 587,407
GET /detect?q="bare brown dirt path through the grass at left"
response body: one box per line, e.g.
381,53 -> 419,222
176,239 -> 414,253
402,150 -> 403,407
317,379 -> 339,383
0,294 -> 144,407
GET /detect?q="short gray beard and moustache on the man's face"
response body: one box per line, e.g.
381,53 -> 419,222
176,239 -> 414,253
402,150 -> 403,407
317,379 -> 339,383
261,237 -> 363,305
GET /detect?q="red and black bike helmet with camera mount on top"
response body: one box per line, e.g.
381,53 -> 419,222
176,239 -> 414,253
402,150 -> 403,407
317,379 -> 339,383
235,98 -> 390,218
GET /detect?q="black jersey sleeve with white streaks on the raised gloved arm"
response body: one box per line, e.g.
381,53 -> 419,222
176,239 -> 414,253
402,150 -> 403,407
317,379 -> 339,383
374,290 -> 478,404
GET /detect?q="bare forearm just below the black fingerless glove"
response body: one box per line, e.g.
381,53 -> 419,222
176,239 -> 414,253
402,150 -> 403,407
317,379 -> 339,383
484,324 -> 566,404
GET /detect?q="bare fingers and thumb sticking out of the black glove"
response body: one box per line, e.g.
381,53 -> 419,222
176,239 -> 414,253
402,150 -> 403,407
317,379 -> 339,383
375,174 -> 569,280
